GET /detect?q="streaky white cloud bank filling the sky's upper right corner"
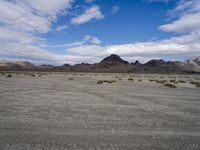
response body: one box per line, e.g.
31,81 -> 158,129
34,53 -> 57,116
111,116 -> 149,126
159,0 -> 200,33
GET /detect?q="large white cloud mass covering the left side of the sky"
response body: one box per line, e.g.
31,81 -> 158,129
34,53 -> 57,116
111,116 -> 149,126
0,0 -> 73,63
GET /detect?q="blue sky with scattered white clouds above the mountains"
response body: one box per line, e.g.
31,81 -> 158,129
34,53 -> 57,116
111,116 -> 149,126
0,0 -> 200,65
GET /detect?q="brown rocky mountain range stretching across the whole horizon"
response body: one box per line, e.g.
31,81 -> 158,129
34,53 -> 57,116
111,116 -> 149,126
0,54 -> 200,73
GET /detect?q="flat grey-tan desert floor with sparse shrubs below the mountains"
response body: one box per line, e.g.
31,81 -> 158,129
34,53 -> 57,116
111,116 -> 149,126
0,73 -> 200,150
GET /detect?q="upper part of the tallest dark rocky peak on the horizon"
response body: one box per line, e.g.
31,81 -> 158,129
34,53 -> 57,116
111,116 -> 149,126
100,54 -> 128,64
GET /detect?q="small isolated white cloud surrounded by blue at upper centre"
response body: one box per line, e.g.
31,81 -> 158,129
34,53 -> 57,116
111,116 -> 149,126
71,6 -> 104,25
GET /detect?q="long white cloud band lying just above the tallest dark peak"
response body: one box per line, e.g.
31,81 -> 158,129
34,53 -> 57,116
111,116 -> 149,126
67,33 -> 200,61
